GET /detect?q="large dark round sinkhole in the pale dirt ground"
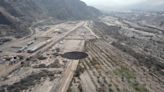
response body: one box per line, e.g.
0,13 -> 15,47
62,51 -> 88,60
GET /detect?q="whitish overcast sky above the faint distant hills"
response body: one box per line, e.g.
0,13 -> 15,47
82,0 -> 164,11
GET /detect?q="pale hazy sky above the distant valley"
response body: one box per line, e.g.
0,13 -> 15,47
81,0 -> 164,8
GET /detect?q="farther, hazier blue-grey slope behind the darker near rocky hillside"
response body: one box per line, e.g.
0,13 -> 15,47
33,0 -> 101,19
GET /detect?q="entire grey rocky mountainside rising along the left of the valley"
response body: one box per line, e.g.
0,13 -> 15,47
0,0 -> 101,35
